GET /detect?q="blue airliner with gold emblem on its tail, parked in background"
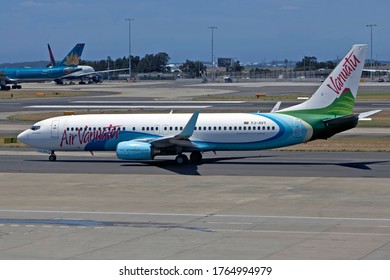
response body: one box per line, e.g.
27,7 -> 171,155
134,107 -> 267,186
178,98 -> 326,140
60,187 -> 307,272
0,44 -> 85,90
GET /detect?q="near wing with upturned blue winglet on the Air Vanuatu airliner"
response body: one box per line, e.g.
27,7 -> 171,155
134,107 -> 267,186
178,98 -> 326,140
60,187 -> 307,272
133,111 -> 199,148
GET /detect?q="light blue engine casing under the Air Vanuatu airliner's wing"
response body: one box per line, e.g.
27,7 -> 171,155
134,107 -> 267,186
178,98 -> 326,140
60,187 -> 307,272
116,141 -> 153,160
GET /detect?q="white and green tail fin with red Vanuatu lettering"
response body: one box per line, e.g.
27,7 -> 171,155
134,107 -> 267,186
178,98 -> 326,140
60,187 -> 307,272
277,44 -> 368,117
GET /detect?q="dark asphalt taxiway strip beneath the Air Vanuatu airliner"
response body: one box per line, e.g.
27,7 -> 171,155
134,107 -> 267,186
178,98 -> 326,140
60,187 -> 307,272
0,150 -> 390,178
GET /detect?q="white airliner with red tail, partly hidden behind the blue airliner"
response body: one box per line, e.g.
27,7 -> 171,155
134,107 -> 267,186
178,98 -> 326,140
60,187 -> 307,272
47,44 -> 129,85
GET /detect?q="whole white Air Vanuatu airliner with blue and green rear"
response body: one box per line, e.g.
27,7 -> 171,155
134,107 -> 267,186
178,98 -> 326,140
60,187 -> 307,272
18,45 -> 379,164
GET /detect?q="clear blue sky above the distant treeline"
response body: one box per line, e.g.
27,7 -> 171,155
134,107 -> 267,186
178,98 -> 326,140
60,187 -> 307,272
0,0 -> 390,63
